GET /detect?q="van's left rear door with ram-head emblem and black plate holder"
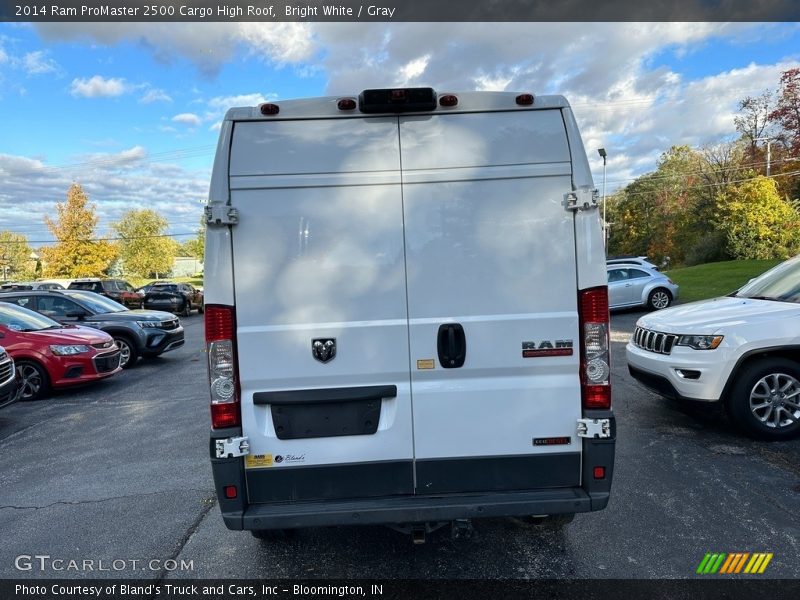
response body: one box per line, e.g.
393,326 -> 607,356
225,117 -> 413,503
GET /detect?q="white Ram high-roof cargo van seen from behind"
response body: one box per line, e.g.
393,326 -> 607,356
205,88 -> 615,536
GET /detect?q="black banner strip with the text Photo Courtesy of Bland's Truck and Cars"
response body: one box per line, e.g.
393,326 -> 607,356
0,575 -> 800,600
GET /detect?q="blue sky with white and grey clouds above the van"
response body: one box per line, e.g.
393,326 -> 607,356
0,23 -> 800,246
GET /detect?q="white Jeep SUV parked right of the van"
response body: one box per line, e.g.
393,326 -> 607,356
626,256 -> 800,440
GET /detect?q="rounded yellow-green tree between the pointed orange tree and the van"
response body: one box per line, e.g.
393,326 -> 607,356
111,209 -> 178,277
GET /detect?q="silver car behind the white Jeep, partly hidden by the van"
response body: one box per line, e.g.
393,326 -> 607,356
607,264 -> 678,310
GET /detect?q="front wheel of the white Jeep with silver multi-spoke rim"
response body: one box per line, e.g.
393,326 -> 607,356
728,358 -> 800,440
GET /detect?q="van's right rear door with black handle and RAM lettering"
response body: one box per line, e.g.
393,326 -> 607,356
400,110 -> 581,494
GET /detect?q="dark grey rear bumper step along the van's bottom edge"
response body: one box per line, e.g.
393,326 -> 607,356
223,487 -> 608,530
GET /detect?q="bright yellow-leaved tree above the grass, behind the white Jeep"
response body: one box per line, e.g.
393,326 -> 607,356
717,177 -> 800,259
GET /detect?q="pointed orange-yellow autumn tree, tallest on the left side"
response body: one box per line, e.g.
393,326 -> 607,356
41,183 -> 116,278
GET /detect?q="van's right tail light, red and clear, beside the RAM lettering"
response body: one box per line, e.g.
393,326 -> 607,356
578,286 -> 611,409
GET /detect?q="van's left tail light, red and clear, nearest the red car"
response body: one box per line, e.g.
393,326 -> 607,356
205,304 -> 242,429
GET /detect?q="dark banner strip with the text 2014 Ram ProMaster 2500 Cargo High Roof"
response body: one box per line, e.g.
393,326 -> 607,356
0,0 -> 800,22
